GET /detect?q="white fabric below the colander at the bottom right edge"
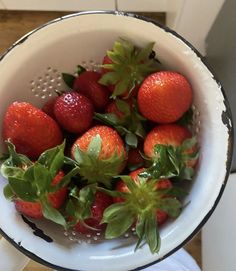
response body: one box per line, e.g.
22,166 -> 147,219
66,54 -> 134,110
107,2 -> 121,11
143,249 -> 201,271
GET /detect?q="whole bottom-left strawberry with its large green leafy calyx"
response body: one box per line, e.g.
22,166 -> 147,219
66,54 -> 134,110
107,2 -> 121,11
1,141 -> 78,226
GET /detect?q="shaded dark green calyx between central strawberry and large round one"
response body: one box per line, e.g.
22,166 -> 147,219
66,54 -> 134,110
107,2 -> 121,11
94,98 -> 146,148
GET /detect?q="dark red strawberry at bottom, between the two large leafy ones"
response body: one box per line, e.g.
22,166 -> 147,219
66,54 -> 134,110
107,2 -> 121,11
74,191 -> 112,234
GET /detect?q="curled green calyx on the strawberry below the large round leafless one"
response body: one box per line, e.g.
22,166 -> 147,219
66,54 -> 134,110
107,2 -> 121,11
141,137 -> 199,180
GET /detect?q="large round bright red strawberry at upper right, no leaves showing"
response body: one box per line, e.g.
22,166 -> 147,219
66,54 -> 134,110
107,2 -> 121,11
138,71 -> 193,123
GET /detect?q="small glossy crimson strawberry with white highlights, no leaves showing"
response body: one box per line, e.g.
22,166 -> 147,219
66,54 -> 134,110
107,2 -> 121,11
54,91 -> 94,133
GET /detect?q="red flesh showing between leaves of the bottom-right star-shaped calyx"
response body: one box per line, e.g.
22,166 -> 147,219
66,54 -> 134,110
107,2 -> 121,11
114,168 -> 172,225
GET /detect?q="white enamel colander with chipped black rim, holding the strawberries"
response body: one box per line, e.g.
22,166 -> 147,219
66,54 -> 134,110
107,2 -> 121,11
0,11 -> 233,271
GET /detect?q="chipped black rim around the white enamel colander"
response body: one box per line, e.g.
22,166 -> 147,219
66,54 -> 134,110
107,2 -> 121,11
0,11 -> 234,271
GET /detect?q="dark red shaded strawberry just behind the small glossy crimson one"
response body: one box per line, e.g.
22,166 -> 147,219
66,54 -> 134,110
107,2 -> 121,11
73,71 -> 109,111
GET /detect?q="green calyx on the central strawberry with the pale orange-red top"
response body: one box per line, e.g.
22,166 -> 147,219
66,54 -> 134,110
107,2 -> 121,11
73,134 -> 126,187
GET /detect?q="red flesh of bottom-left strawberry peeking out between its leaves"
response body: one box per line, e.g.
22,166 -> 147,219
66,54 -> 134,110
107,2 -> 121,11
14,171 -> 68,219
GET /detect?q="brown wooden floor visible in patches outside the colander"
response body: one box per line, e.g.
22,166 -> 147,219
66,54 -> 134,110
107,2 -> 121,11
0,11 -> 201,271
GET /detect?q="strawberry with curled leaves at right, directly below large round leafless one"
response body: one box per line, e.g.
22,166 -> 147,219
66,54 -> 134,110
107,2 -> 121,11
144,124 -> 198,179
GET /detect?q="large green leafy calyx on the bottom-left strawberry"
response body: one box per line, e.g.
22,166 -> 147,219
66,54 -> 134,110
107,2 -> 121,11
0,140 -> 78,227
